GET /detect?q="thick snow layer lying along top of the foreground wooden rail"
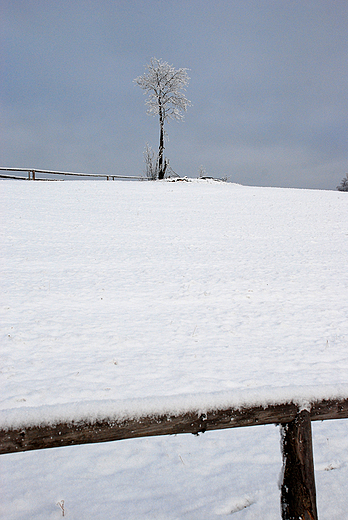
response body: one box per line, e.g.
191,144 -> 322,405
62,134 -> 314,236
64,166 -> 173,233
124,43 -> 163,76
0,385 -> 348,429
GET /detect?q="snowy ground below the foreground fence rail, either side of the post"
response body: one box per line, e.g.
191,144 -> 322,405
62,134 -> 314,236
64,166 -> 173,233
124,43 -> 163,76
0,420 -> 348,520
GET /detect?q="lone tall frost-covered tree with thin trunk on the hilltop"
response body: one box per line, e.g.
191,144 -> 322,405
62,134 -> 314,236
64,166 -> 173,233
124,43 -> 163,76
134,58 -> 191,179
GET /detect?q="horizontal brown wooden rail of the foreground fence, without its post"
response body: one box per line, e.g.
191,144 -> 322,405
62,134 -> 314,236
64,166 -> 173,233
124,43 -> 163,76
0,399 -> 348,454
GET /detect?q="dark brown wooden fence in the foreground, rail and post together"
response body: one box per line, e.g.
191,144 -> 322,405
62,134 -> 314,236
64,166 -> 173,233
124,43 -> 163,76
0,399 -> 348,520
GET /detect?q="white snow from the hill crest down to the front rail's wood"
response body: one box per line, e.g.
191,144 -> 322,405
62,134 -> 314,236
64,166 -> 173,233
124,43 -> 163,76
1,181 -> 348,426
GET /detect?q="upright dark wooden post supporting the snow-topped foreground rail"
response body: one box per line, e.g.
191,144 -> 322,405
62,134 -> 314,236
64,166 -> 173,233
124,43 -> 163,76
281,410 -> 318,520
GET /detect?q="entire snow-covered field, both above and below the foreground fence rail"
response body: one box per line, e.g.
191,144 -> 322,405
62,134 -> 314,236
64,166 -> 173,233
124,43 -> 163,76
0,181 -> 348,520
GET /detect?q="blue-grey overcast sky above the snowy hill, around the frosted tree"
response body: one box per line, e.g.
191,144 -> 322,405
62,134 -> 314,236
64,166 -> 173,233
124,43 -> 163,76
0,0 -> 348,189
